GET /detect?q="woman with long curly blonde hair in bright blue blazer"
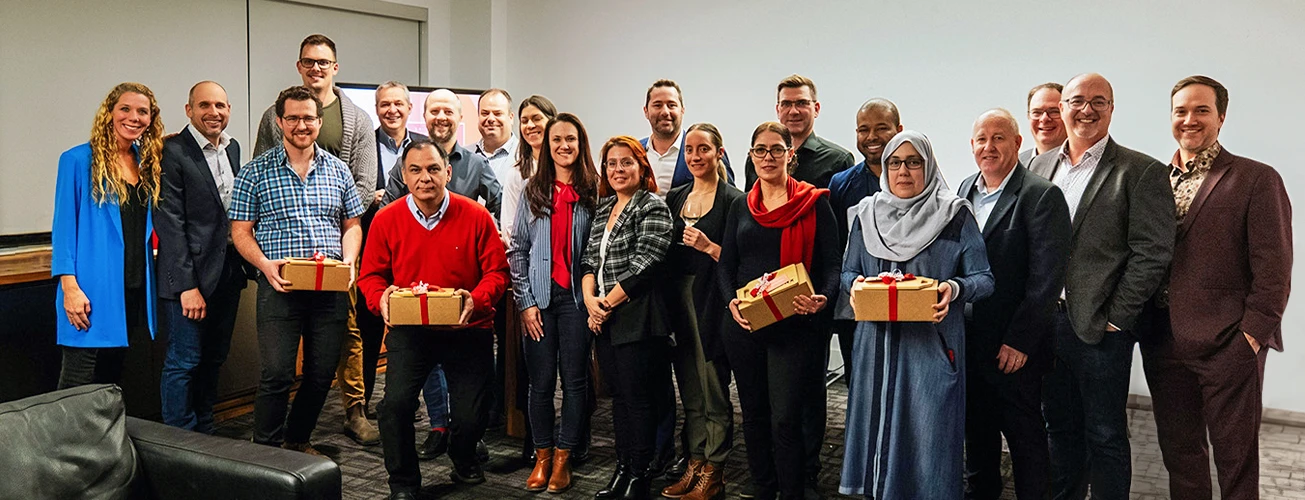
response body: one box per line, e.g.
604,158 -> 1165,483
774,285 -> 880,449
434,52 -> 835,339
51,82 -> 163,399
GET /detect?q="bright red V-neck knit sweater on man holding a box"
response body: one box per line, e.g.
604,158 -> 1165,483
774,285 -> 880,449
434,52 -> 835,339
358,192 -> 509,328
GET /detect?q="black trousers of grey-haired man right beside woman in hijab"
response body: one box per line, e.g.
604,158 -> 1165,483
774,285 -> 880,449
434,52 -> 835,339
966,359 -> 1051,500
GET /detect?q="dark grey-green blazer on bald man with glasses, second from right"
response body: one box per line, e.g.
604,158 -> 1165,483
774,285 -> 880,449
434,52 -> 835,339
1028,138 -> 1177,345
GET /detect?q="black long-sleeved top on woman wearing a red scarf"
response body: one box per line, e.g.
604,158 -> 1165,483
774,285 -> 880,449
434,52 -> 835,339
716,196 -> 843,333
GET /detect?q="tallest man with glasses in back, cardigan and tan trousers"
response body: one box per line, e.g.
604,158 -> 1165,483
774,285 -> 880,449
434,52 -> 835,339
253,34 -> 381,445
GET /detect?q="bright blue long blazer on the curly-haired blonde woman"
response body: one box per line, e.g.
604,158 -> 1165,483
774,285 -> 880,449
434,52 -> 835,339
50,142 -> 155,347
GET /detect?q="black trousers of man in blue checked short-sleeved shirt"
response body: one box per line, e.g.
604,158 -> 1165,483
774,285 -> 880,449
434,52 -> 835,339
253,277 -> 348,445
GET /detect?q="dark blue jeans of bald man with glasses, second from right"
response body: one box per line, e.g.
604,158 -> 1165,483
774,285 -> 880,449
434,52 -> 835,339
1043,312 -> 1137,500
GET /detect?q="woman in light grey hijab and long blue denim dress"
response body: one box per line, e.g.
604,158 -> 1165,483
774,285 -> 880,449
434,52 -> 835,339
839,131 -> 993,500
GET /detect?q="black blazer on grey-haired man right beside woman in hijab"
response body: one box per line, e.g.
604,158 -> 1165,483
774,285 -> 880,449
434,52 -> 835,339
957,164 -> 1070,368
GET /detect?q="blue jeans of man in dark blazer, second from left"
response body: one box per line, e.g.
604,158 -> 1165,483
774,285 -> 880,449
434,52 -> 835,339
158,283 -> 243,433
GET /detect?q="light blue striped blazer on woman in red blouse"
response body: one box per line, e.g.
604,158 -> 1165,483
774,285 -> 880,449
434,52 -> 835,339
508,189 -> 594,312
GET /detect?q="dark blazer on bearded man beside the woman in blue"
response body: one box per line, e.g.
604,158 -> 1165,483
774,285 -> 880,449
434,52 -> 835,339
154,125 -> 245,300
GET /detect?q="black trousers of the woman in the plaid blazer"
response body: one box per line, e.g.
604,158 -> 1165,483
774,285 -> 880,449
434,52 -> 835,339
595,332 -> 671,470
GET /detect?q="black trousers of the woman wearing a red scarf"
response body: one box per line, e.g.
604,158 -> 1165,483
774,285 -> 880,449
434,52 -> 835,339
723,325 -> 829,499
